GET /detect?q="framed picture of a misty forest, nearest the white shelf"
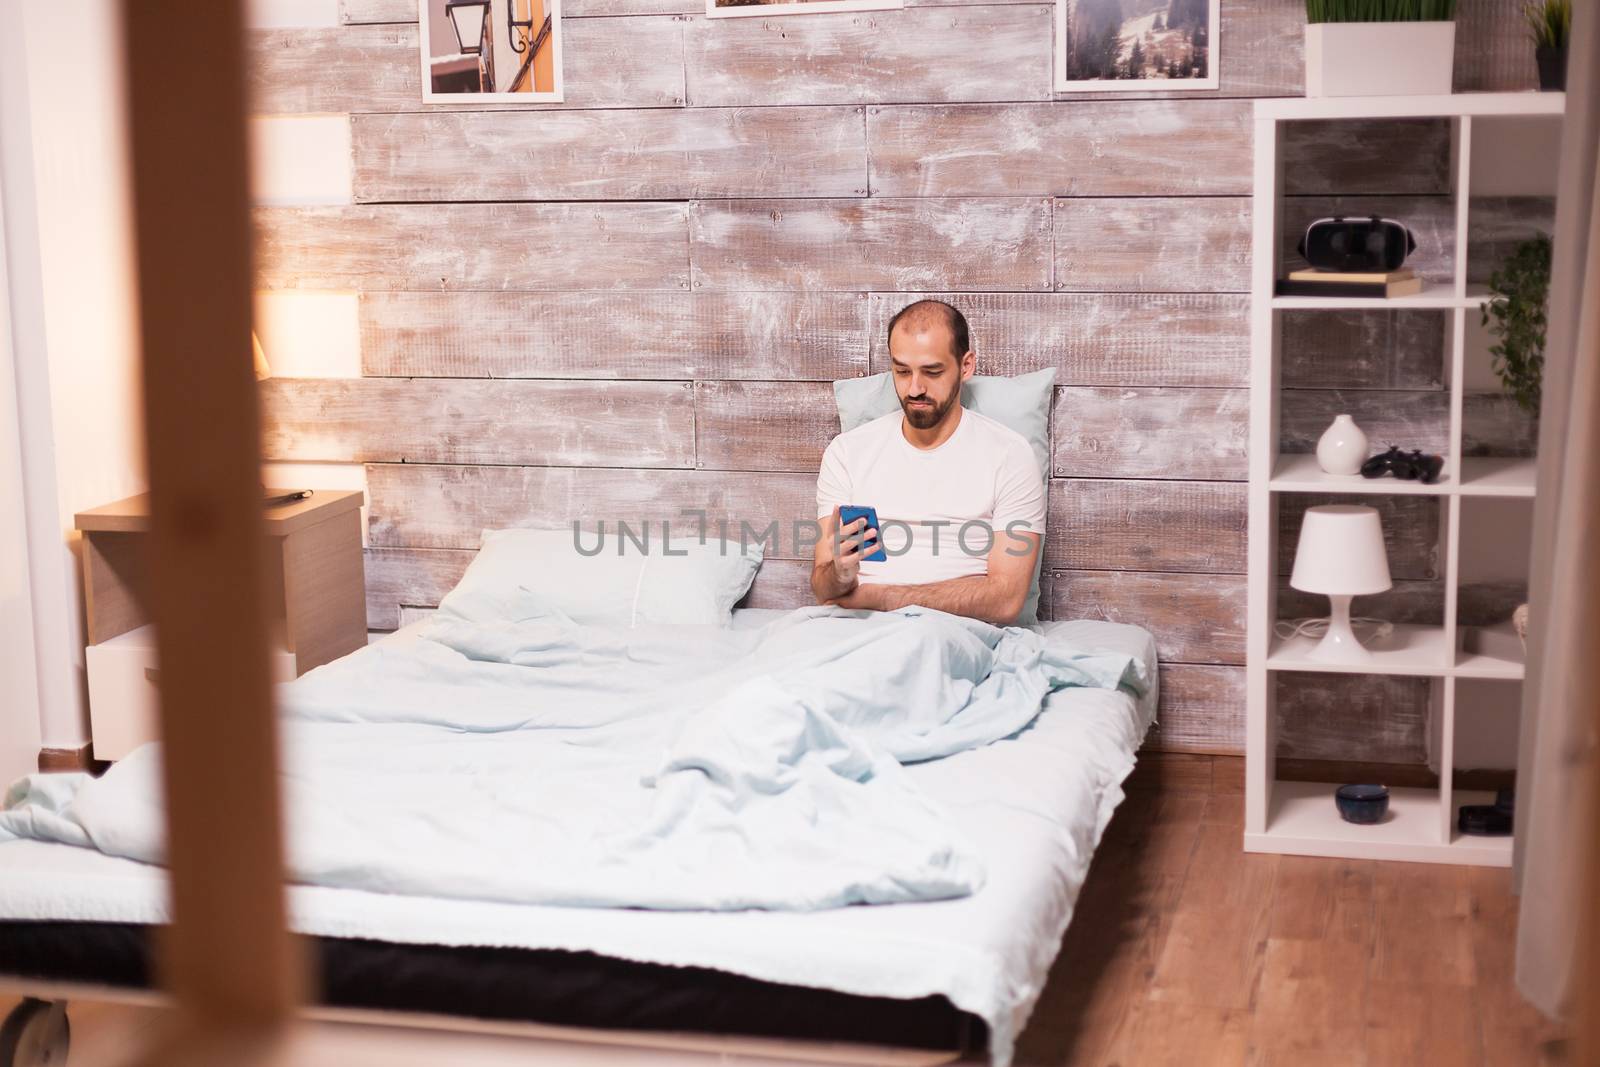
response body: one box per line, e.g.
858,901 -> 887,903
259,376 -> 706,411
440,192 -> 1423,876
1056,0 -> 1221,93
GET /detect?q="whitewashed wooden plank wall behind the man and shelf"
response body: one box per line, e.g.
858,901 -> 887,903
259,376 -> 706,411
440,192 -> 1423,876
251,0 -> 1549,763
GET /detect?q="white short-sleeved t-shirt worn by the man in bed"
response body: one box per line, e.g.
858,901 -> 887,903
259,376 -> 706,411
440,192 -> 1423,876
816,408 -> 1045,585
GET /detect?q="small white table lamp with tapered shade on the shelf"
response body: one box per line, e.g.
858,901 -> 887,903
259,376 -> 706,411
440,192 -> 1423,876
1290,504 -> 1394,664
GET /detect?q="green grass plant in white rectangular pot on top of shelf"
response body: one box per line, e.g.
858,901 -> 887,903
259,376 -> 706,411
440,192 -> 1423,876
1306,0 -> 1456,96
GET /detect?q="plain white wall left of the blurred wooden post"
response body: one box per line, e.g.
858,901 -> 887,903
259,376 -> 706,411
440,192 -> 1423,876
0,0 -> 146,749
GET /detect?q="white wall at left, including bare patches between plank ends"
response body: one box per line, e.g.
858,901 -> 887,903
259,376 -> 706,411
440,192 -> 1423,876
0,0 -> 365,767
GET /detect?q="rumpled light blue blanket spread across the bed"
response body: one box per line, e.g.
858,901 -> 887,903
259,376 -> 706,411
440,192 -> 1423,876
0,606 -> 1150,910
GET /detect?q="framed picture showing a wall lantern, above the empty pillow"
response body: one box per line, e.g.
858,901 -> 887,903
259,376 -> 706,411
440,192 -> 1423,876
418,0 -> 562,104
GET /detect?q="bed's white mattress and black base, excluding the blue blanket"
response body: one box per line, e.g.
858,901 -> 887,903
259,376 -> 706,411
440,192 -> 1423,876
0,609 -> 1157,1064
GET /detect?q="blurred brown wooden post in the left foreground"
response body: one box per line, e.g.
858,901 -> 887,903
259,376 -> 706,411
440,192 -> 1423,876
122,0 -> 302,1027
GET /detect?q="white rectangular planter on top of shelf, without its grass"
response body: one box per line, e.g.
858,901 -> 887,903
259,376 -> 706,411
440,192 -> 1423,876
1306,22 -> 1456,96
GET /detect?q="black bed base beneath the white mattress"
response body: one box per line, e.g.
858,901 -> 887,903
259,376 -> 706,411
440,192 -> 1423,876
0,920 -> 987,1051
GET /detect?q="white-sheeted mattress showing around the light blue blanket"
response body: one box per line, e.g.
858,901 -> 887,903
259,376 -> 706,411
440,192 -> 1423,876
0,609 -> 1157,1062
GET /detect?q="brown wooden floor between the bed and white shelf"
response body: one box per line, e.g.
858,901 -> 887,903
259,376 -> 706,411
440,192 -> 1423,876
0,780 -> 1565,1067
